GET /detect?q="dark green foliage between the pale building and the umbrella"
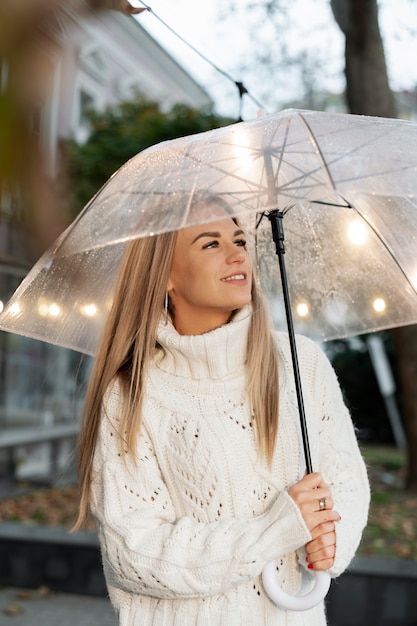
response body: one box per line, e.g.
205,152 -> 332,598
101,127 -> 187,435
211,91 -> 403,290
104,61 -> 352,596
63,99 -> 234,217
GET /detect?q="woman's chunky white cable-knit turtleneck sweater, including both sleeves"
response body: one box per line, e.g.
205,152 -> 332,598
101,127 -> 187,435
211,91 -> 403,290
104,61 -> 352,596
92,308 -> 369,626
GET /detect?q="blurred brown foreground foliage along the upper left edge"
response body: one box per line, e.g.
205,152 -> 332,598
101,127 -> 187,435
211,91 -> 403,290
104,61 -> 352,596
0,0 -> 146,262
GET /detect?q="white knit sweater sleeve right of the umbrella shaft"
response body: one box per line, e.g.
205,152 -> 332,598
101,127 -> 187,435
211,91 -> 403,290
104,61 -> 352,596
308,342 -> 370,576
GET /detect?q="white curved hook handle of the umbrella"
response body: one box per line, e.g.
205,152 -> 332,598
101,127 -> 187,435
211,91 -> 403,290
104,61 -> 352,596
262,561 -> 331,611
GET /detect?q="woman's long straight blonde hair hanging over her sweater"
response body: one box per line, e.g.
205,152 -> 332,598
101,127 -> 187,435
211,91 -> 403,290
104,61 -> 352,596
73,202 -> 278,531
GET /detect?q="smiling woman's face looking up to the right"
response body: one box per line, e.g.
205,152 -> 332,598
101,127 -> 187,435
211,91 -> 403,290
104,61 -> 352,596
167,218 -> 252,335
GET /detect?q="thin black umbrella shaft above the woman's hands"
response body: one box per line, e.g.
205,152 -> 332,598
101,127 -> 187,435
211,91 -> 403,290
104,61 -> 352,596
268,210 -> 313,474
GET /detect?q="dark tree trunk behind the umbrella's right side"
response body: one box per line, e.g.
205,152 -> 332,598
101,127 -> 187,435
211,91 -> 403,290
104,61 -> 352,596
330,0 -> 417,492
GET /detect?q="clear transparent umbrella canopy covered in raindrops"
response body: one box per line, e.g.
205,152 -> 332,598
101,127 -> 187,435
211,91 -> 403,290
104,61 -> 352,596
0,110 -> 417,354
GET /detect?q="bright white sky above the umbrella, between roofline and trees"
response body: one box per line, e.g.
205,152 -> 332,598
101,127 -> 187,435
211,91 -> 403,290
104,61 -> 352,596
131,0 -> 417,119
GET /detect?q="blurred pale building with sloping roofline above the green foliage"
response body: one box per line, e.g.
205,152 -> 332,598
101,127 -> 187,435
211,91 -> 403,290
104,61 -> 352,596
42,10 -> 212,170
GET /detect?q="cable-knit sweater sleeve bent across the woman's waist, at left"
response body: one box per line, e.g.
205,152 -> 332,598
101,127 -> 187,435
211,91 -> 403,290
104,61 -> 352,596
91,382 -> 310,598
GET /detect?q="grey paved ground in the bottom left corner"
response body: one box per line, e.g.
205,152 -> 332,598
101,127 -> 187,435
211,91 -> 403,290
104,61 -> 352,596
0,589 -> 117,626
